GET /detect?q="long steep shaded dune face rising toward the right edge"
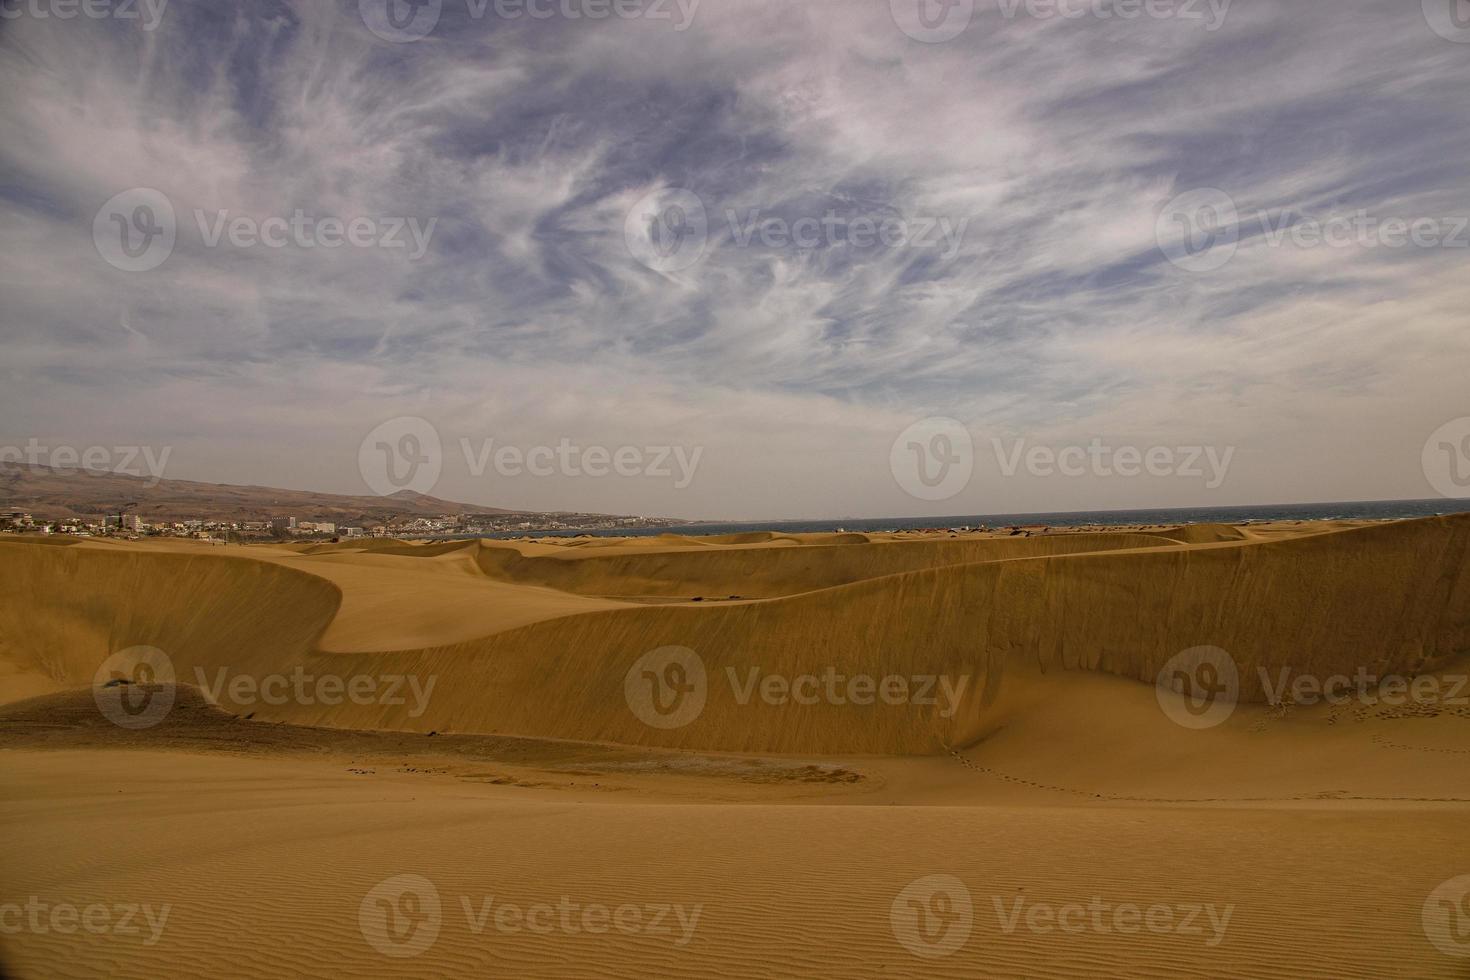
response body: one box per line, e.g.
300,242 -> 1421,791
352,519 -> 1470,752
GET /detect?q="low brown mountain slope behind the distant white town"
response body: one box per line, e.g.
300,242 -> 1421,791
0,463 -> 596,526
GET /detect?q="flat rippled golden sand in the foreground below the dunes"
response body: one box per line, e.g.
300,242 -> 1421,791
0,751 -> 1470,980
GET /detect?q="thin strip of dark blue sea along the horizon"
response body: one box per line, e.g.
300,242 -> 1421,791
476,498 -> 1470,538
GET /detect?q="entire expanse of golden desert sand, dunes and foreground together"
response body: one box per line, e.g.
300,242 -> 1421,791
0,516 -> 1470,977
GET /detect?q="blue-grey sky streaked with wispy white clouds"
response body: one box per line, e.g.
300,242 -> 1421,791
0,0 -> 1470,520
